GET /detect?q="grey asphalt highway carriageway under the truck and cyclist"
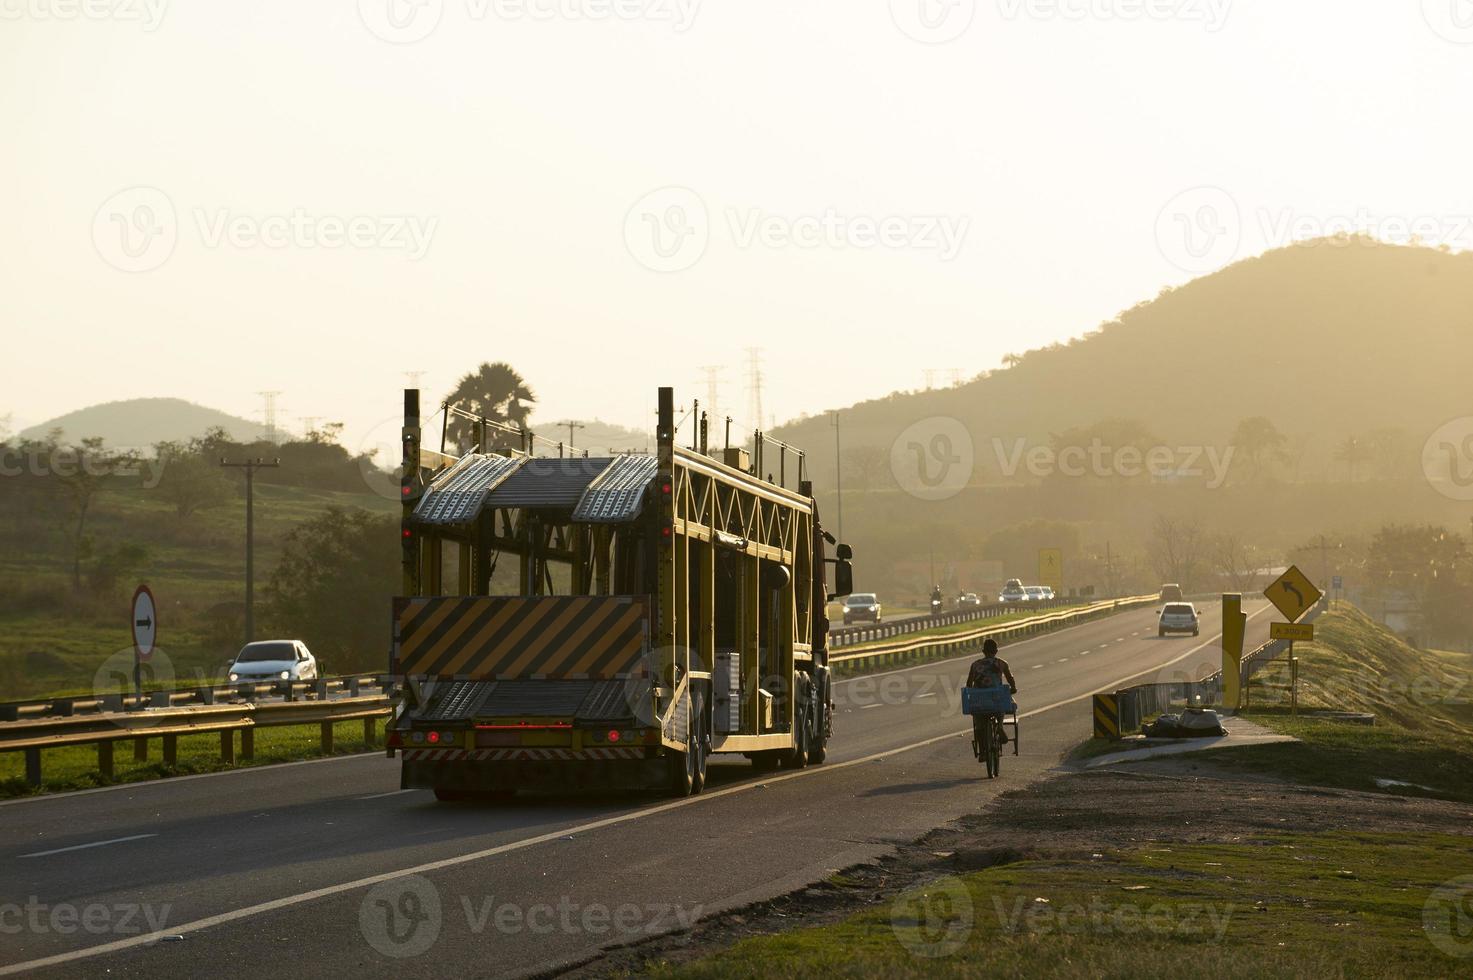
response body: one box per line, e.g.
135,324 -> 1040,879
0,601 -> 1271,980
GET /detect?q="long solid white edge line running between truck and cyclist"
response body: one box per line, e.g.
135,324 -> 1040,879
0,604 -> 1271,977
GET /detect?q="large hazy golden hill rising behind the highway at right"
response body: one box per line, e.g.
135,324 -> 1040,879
775,239 -> 1473,479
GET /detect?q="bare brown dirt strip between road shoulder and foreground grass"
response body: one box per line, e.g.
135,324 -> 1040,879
564,757 -> 1473,977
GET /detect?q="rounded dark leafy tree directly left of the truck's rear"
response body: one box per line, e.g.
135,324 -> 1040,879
264,507 -> 401,672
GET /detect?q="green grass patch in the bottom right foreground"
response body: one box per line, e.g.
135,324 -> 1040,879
647,833 -> 1473,979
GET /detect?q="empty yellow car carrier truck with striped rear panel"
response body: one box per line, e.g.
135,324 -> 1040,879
387,388 -> 853,800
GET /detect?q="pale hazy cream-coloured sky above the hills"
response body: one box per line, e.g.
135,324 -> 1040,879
0,0 -> 1473,453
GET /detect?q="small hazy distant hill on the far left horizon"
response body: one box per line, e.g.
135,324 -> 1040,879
21,398 -> 262,448
